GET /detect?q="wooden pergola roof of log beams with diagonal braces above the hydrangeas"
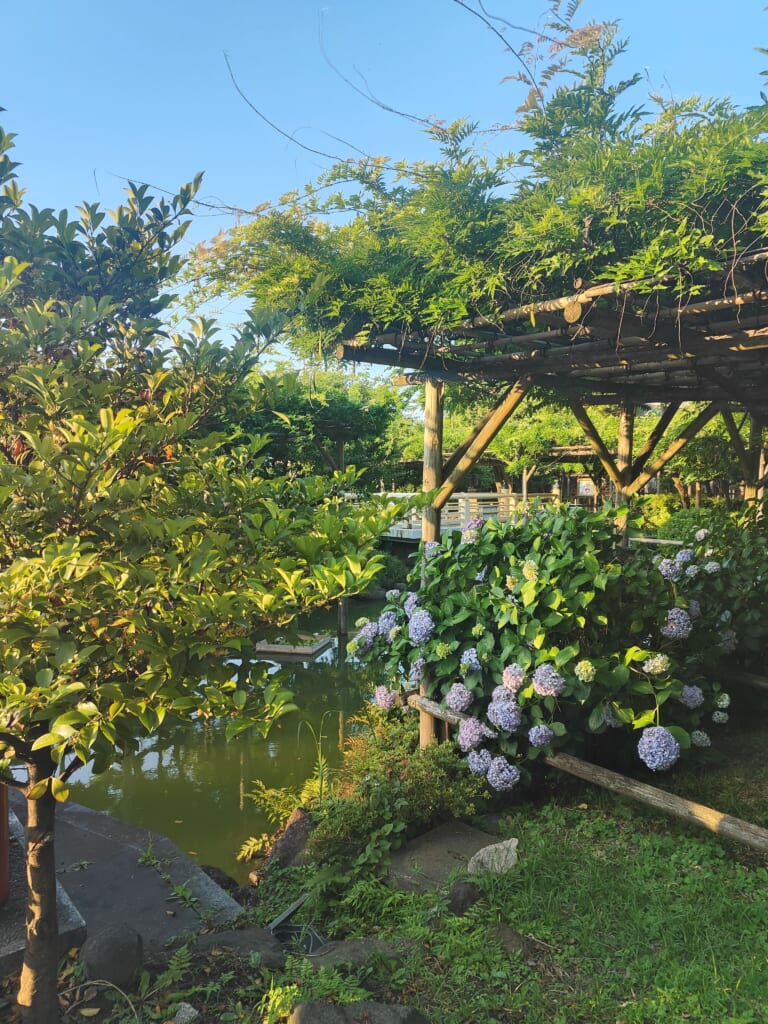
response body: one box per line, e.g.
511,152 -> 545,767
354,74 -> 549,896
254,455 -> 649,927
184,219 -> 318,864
337,249 -> 768,540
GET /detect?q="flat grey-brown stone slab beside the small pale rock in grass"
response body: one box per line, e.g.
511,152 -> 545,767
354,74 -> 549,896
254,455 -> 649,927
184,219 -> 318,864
389,821 -> 499,892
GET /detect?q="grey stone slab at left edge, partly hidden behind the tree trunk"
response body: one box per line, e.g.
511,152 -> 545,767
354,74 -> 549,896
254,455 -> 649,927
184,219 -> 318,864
0,811 -> 86,977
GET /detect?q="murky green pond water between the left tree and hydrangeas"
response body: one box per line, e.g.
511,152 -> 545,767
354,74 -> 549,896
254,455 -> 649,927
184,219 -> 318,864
71,602 -> 383,881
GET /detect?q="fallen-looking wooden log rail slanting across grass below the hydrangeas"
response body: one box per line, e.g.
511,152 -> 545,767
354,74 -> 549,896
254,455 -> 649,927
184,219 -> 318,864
543,754 -> 768,853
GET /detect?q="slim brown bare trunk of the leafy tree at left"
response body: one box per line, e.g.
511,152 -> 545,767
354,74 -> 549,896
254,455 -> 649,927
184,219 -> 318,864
18,752 -> 59,1024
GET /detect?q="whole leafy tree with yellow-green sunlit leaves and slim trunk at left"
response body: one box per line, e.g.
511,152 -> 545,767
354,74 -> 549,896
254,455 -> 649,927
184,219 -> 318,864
0,133 -> 409,1024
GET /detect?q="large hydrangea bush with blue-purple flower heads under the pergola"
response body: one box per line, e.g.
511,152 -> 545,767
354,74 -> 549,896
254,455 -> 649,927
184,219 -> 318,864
350,505 -> 768,790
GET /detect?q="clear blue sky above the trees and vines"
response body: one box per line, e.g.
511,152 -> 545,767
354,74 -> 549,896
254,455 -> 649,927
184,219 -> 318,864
0,0 -> 768,268
